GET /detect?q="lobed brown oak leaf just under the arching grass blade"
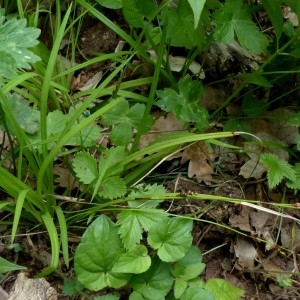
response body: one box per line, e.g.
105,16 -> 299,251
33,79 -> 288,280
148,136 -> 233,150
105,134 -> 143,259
181,141 -> 215,184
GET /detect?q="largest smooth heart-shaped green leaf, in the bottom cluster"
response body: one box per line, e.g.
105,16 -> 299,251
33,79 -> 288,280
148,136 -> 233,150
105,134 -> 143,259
74,215 -> 131,291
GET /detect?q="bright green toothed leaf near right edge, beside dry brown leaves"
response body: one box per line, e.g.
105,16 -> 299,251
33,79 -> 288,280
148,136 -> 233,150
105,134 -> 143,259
260,153 -> 296,189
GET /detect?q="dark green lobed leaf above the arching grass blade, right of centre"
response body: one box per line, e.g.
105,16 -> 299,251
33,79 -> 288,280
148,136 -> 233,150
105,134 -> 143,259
157,77 -> 209,130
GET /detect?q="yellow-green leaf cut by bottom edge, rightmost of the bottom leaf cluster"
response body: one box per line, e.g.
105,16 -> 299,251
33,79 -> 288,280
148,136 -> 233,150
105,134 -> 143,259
204,278 -> 245,300
